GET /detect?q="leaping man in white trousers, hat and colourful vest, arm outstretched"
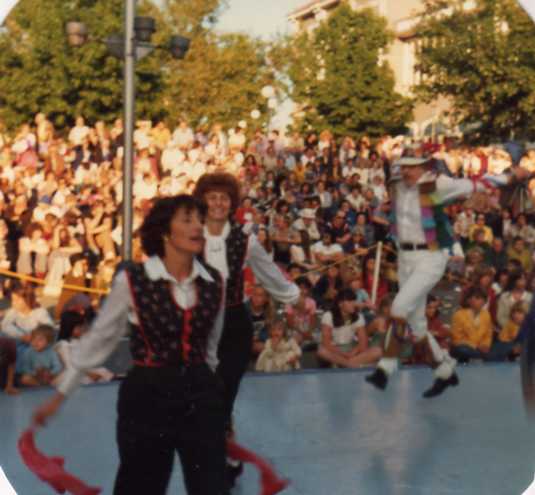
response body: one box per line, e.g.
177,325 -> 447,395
366,157 -> 529,398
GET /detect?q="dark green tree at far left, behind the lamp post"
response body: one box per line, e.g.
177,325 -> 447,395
0,0 -> 163,128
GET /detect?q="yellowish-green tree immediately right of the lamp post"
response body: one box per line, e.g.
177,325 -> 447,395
164,0 -> 274,130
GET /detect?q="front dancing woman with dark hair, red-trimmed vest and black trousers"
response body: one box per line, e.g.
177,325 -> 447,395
34,194 -> 227,495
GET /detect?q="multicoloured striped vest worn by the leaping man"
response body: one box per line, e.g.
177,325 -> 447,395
390,178 -> 454,250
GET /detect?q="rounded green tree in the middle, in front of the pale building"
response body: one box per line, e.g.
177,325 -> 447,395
272,4 -> 412,137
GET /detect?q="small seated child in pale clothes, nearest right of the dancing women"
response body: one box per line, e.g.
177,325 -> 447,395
255,320 -> 302,372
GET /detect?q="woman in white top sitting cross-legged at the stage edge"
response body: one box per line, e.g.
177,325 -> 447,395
318,289 -> 382,368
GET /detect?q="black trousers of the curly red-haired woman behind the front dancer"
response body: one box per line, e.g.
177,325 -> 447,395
217,304 -> 254,424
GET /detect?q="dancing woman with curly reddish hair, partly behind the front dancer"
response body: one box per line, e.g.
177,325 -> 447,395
194,172 -> 299,482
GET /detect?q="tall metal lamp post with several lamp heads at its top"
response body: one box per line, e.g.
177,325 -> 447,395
66,0 -> 190,261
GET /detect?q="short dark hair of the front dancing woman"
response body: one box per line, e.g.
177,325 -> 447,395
139,194 -> 206,256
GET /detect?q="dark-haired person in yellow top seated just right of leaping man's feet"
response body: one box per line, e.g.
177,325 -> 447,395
451,287 -> 492,363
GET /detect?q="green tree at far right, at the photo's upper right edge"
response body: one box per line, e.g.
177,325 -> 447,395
416,0 -> 535,141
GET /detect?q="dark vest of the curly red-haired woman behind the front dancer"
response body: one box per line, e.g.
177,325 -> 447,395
226,225 -> 249,306
